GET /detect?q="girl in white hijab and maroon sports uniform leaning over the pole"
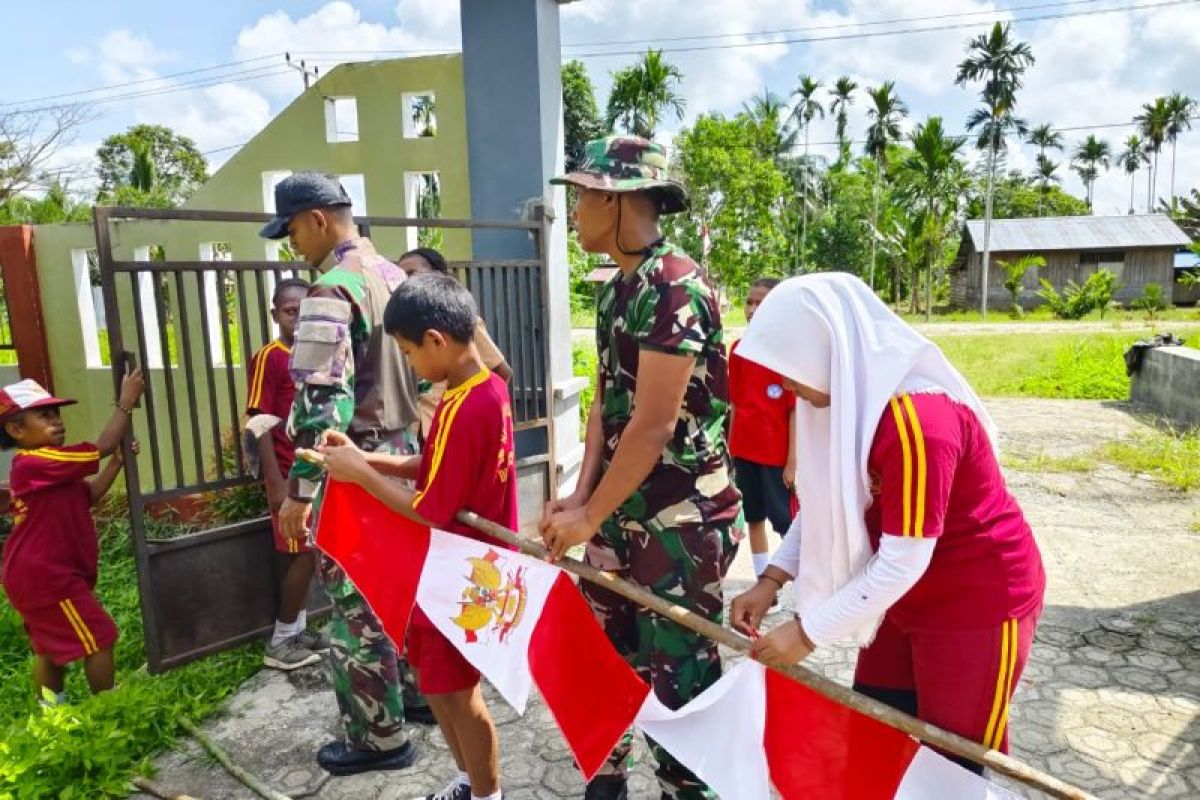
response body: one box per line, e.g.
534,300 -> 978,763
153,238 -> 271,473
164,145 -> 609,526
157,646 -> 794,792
732,272 -> 1045,769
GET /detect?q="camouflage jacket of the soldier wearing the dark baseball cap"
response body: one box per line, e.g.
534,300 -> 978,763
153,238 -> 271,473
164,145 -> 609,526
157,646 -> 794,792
288,239 -> 419,499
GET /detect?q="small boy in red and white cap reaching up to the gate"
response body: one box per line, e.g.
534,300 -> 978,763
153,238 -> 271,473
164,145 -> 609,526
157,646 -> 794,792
0,369 -> 145,703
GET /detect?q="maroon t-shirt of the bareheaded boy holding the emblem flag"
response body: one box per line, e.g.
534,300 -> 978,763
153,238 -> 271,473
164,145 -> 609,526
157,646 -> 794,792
413,369 -> 517,549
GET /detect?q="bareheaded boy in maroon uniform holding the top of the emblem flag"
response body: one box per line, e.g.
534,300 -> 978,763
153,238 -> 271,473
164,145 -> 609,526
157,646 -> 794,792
322,272 -> 517,800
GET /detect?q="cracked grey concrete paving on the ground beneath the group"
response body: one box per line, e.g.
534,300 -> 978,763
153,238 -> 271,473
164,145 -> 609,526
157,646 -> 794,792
137,399 -> 1200,800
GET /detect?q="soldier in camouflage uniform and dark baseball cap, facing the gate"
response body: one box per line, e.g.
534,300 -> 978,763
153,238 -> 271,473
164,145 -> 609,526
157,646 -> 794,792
262,173 -> 427,775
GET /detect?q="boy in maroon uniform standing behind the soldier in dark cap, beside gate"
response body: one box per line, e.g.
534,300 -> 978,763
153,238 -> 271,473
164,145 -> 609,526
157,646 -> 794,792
246,278 -> 329,670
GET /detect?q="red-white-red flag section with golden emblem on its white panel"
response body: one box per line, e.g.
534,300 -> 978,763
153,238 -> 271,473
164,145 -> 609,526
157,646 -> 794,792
317,481 -> 649,777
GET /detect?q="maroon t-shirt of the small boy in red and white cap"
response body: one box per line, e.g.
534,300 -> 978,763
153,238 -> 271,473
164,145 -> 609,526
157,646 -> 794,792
0,444 -> 100,610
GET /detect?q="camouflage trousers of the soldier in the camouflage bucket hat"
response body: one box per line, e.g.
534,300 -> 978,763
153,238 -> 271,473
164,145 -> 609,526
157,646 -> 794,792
580,521 -> 740,800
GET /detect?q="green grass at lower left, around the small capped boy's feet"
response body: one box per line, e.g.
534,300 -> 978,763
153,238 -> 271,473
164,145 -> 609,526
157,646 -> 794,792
0,506 -> 262,800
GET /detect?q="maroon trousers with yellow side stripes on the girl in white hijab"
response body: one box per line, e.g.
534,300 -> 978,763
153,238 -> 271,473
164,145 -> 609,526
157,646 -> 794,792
854,609 -> 1040,753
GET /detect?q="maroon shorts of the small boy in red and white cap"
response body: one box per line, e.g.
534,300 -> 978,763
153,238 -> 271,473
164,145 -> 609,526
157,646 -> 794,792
20,587 -> 116,667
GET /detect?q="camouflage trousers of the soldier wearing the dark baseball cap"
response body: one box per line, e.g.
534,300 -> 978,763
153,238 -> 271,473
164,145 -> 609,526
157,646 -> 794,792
314,431 -> 425,751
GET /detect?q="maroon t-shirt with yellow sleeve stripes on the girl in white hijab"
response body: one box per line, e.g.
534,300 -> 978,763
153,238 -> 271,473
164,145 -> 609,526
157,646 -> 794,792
866,393 -> 1045,630
